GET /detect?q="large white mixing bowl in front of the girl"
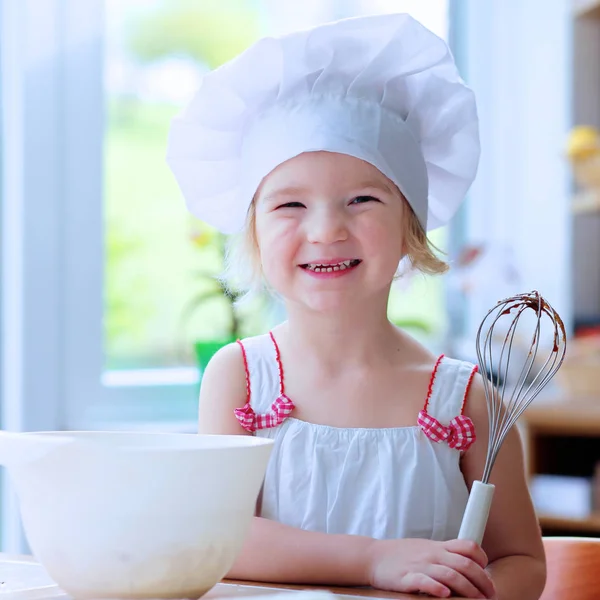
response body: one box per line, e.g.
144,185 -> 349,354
0,432 -> 272,600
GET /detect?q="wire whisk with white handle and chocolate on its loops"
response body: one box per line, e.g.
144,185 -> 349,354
458,291 -> 567,544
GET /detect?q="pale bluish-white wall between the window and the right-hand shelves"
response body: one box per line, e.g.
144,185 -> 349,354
454,0 -> 573,343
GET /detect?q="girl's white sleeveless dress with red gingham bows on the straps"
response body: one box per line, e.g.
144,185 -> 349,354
236,334 -> 477,540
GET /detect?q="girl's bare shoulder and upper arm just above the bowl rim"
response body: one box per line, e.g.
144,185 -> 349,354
198,343 -> 248,434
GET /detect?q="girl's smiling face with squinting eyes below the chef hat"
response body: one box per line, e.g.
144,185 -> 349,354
256,152 -> 407,311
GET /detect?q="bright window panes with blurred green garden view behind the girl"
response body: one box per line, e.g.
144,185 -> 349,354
103,0 -> 447,414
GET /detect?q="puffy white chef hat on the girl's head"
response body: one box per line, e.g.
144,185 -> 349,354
167,14 -> 480,233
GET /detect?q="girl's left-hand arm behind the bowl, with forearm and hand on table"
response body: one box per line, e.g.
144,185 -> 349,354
199,344 -> 493,598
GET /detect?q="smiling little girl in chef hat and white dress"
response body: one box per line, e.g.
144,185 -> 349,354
168,10 -> 545,600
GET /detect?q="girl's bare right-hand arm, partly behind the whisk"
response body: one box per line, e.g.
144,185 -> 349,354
462,376 -> 546,600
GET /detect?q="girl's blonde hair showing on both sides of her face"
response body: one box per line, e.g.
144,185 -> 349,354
222,194 -> 449,301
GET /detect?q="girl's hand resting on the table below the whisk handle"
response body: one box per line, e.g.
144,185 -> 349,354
368,539 -> 496,600
